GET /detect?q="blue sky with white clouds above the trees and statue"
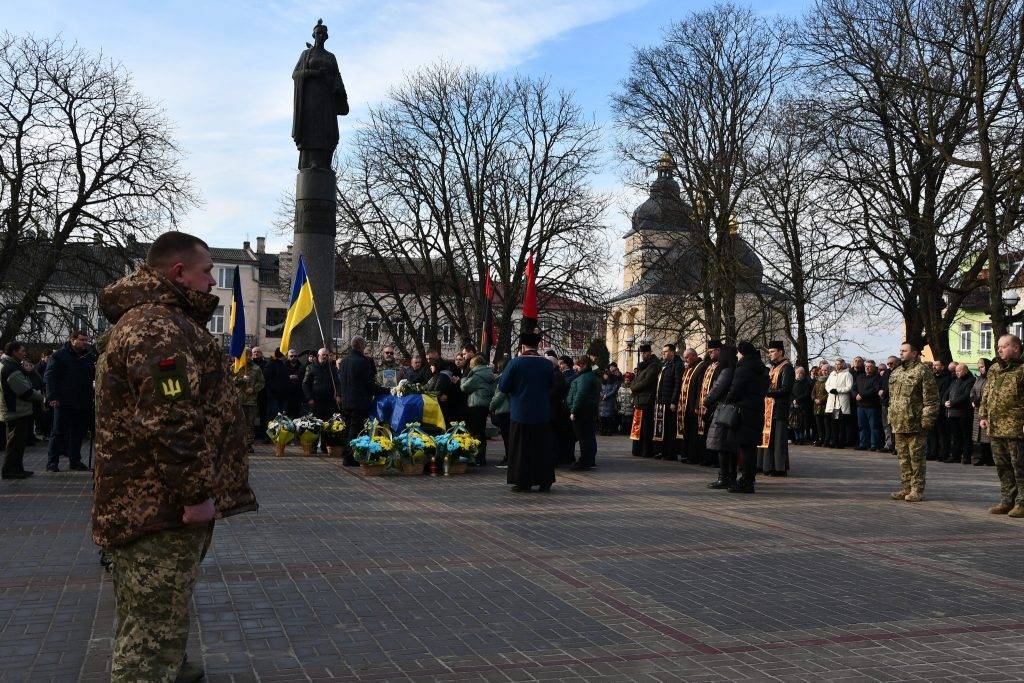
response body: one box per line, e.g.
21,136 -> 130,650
0,0 -> 888,358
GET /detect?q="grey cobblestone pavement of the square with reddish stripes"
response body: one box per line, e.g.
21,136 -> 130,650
0,437 -> 1024,682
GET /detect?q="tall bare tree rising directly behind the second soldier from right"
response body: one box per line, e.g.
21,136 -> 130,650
801,0 -> 983,359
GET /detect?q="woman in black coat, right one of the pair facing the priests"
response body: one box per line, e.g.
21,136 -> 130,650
725,341 -> 768,494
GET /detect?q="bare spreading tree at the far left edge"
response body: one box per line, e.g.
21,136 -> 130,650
0,34 -> 195,343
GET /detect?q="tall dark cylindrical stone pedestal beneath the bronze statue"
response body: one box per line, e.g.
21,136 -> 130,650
292,168 -> 338,353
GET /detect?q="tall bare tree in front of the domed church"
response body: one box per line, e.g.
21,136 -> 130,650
613,4 -> 790,339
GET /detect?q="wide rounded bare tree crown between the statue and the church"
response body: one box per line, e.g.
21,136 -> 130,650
339,65 -> 607,360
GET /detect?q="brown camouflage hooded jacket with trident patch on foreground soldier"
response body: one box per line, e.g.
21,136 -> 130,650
92,266 -> 257,547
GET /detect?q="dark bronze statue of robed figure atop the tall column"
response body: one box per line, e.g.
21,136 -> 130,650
292,19 -> 348,170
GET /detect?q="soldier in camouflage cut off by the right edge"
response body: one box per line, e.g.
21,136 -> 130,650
978,335 -> 1024,517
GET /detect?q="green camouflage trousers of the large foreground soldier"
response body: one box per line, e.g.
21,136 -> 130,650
108,522 -> 213,682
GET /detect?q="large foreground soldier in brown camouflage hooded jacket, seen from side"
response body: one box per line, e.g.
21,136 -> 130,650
92,232 -> 257,682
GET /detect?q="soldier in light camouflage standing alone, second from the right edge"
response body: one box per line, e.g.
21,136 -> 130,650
889,344 -> 939,503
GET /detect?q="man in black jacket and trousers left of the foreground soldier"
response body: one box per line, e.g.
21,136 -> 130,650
43,330 -> 96,472
